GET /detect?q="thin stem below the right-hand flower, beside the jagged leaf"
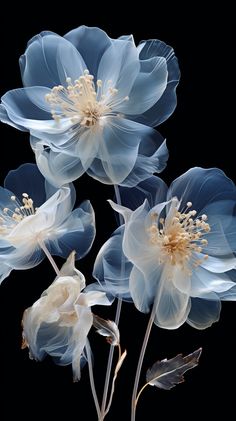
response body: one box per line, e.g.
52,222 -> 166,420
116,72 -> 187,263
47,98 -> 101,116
131,303 -> 156,421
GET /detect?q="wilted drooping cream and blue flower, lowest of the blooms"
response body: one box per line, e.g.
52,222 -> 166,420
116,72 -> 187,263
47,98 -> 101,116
22,252 -> 110,381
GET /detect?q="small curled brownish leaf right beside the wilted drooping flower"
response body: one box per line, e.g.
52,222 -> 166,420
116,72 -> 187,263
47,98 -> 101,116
93,314 -> 120,346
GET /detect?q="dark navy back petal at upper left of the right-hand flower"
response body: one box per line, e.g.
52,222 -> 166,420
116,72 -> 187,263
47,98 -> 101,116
119,176 -> 167,210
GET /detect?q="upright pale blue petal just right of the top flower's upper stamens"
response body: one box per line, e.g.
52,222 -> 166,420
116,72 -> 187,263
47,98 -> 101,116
98,40 -> 140,97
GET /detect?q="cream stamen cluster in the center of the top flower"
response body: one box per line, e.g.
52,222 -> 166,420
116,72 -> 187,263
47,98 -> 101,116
45,70 -> 129,127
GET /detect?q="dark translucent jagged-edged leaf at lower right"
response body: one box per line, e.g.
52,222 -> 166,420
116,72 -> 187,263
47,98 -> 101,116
146,348 -> 202,390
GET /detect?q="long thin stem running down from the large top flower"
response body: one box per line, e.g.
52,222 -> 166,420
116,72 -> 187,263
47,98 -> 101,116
100,185 -> 124,421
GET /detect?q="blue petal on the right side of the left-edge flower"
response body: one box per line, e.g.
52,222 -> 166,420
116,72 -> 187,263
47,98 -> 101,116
48,201 -> 95,259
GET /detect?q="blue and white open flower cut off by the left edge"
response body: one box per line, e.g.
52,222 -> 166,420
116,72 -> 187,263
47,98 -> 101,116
0,164 -> 95,282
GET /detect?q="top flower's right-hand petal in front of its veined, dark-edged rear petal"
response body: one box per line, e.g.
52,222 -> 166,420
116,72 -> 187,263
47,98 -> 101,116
117,57 -> 168,115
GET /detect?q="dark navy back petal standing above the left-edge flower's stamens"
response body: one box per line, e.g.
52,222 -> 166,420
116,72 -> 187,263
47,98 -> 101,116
4,164 -> 46,207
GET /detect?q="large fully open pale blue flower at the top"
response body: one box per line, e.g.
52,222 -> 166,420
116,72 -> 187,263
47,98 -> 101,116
0,26 -> 180,187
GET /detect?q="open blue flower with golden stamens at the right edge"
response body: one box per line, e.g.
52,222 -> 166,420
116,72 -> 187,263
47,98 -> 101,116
94,168 -> 236,329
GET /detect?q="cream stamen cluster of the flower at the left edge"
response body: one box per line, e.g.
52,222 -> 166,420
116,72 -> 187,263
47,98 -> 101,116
0,193 -> 37,235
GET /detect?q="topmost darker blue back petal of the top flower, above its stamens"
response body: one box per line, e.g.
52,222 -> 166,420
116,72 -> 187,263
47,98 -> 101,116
64,25 -> 112,78
